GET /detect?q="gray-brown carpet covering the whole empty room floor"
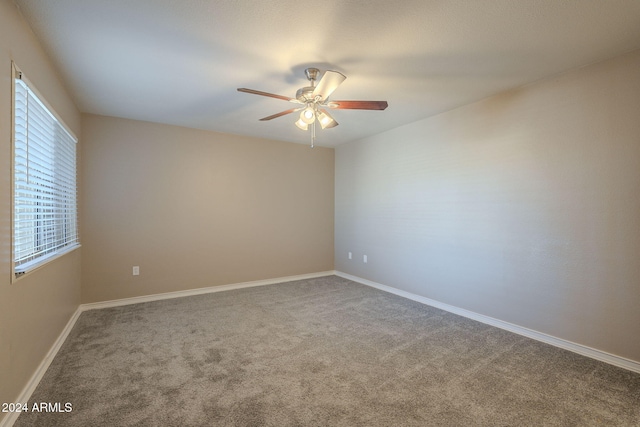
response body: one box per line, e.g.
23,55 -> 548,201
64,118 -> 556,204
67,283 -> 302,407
16,276 -> 640,427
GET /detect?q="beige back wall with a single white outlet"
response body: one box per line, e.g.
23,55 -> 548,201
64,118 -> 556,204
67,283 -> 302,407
81,115 -> 334,302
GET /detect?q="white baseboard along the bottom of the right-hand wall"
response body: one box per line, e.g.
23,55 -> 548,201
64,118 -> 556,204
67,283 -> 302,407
335,271 -> 640,373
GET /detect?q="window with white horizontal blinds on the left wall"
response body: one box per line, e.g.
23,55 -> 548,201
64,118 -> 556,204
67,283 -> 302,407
12,62 -> 78,277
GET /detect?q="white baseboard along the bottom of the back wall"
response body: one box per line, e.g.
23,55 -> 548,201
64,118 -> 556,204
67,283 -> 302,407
80,270 -> 335,311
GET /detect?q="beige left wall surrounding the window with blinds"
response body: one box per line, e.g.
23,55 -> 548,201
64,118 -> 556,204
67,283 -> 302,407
0,0 -> 81,420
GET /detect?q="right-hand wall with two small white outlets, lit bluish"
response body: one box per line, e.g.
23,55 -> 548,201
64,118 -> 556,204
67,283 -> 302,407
335,51 -> 640,362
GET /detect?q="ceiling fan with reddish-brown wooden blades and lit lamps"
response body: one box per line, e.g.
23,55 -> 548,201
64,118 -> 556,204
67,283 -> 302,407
238,68 -> 388,148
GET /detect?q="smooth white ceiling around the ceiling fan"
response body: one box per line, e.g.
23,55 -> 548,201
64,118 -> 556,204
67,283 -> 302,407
15,0 -> 640,146
